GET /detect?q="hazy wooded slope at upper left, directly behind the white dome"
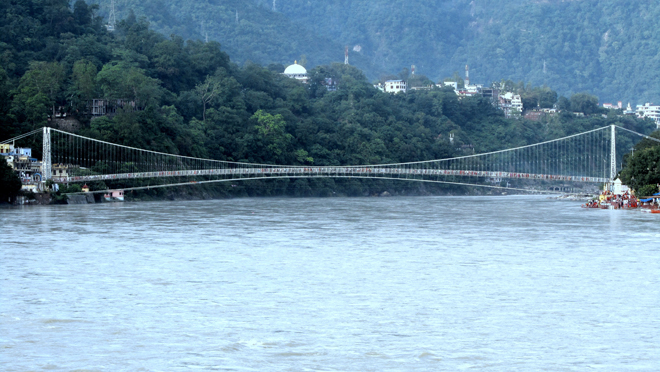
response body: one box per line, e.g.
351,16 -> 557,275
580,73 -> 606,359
85,0 -> 370,71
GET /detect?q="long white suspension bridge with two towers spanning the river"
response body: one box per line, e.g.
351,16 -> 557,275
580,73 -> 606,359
0,125 -> 660,195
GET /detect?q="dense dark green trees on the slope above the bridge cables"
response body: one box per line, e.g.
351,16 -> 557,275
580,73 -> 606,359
0,0 -> 654,195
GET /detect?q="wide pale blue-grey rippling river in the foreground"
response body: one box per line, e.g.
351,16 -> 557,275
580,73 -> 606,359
0,196 -> 660,371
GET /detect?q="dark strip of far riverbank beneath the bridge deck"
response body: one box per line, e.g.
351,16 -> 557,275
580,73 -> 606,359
7,178 -> 597,205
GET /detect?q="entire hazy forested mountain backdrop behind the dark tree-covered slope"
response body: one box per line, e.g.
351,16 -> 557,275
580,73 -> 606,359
89,0 -> 660,105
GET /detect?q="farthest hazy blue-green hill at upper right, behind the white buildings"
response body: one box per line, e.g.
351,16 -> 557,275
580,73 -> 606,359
270,0 -> 660,104
